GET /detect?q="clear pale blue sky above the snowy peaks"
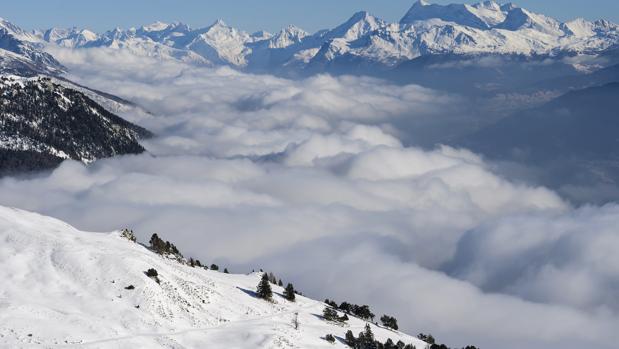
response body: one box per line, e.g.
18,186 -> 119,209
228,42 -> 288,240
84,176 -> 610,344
0,0 -> 619,31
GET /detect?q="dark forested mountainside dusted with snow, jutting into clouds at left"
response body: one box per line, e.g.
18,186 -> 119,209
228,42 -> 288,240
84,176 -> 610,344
0,76 -> 150,174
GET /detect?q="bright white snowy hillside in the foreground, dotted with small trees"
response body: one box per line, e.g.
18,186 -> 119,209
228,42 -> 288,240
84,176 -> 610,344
0,206 -> 426,349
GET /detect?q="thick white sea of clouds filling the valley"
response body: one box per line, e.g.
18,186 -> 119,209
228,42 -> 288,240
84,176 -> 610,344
0,49 -> 619,349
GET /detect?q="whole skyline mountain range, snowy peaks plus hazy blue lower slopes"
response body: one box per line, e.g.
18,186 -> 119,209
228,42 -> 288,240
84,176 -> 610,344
0,0 -> 619,93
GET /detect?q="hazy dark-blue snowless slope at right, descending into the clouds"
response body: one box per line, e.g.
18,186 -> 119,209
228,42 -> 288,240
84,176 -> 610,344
451,82 -> 619,203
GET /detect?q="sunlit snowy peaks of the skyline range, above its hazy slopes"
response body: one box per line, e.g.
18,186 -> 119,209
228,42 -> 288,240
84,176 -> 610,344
38,0 -> 619,70
